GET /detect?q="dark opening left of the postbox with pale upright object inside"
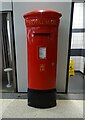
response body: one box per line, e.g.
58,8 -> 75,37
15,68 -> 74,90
0,11 -> 17,92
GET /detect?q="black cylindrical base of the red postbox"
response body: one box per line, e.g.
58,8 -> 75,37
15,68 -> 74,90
28,89 -> 56,108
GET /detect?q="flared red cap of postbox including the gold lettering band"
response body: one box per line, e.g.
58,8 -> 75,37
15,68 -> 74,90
24,10 -> 62,27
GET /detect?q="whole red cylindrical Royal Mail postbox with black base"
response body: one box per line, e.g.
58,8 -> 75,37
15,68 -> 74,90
24,10 -> 61,108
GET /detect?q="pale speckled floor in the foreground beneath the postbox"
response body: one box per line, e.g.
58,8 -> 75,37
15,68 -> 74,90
0,99 -> 83,118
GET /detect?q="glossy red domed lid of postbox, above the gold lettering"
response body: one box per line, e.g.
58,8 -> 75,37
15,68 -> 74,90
24,10 -> 62,18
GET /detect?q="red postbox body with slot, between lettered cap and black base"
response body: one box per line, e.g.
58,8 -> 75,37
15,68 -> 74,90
28,28 -> 57,90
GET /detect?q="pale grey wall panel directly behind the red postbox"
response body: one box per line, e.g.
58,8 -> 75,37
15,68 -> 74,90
13,2 -> 71,92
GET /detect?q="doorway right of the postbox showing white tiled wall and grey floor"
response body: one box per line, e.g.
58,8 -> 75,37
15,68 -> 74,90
66,3 -> 85,94
